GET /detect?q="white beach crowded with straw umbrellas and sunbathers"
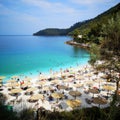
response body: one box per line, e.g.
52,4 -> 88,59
0,64 -> 116,112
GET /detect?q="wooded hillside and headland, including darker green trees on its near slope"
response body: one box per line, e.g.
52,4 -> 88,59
33,3 -> 120,37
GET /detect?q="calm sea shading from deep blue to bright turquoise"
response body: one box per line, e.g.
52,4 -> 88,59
0,36 -> 89,80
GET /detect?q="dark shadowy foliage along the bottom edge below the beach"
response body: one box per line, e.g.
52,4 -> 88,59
0,97 -> 120,120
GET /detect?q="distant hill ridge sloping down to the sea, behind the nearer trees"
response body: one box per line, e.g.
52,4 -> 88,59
33,3 -> 120,36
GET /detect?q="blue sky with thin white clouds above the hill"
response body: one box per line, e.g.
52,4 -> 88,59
0,0 -> 120,35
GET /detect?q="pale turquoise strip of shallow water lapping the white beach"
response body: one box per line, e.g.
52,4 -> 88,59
0,55 -> 89,83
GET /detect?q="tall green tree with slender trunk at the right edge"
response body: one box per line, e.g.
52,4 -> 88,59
100,13 -> 120,103
